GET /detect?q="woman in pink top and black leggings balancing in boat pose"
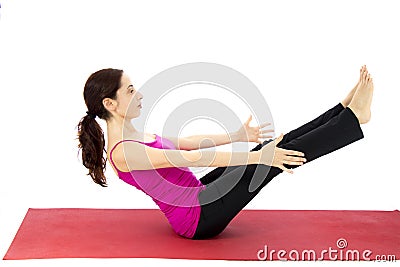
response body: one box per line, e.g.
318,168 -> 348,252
78,65 -> 373,239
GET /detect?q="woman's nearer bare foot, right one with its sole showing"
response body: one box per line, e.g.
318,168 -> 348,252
348,67 -> 374,124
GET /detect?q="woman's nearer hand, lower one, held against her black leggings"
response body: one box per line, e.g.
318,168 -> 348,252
259,134 -> 306,174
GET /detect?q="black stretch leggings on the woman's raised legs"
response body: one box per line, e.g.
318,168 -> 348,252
192,103 -> 364,239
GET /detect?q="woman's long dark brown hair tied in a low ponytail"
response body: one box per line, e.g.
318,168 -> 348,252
77,68 -> 123,187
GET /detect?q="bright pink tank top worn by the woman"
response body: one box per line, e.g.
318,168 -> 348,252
110,134 -> 206,238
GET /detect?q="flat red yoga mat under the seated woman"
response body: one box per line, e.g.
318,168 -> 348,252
4,208 -> 400,261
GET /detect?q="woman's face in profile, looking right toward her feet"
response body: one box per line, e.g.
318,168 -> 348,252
117,73 -> 143,119
